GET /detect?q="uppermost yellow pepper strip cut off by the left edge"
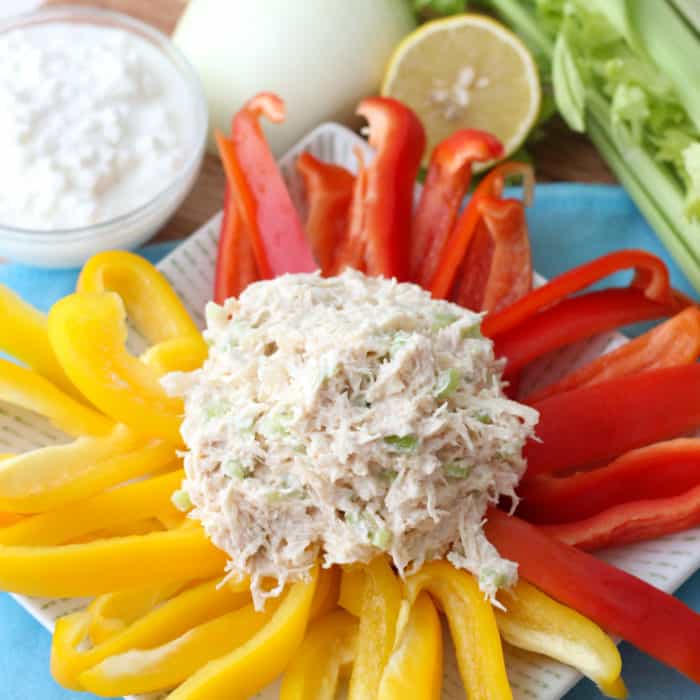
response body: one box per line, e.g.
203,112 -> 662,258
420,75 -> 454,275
0,284 -> 76,395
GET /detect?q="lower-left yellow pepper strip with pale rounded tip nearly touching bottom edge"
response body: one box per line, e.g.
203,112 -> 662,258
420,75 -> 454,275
78,600 -> 279,697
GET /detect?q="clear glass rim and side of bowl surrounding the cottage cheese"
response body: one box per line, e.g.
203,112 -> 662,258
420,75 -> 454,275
0,5 -> 209,268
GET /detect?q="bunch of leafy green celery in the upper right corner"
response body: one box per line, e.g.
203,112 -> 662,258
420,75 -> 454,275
486,0 -> 700,290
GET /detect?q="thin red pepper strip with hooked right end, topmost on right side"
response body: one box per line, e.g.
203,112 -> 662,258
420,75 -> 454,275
482,250 -> 675,338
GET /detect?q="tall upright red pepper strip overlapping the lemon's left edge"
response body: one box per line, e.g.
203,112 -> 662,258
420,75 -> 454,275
337,97 -> 425,281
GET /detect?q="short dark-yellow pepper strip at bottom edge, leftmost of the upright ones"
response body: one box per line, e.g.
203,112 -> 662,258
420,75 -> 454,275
280,610 -> 358,700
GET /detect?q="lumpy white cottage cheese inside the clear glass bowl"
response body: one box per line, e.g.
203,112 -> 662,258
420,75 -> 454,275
0,22 -> 193,230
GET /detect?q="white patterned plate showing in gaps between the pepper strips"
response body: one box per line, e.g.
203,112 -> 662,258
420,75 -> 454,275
0,124 -> 700,700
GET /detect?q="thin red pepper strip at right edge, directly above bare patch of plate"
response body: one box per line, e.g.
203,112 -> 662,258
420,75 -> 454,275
540,486 -> 700,552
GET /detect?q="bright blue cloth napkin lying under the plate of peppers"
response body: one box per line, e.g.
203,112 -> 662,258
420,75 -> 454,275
0,184 -> 700,700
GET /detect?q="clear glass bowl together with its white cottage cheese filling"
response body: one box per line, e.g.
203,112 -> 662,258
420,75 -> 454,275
0,6 -> 208,267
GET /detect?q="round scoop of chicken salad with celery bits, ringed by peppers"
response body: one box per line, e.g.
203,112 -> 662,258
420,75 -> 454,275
163,271 -> 537,607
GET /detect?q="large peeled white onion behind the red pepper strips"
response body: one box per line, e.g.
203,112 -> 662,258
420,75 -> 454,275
175,0 -> 415,155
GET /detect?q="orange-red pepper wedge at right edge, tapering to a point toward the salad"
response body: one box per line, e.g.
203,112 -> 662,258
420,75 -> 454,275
524,306 -> 700,403
